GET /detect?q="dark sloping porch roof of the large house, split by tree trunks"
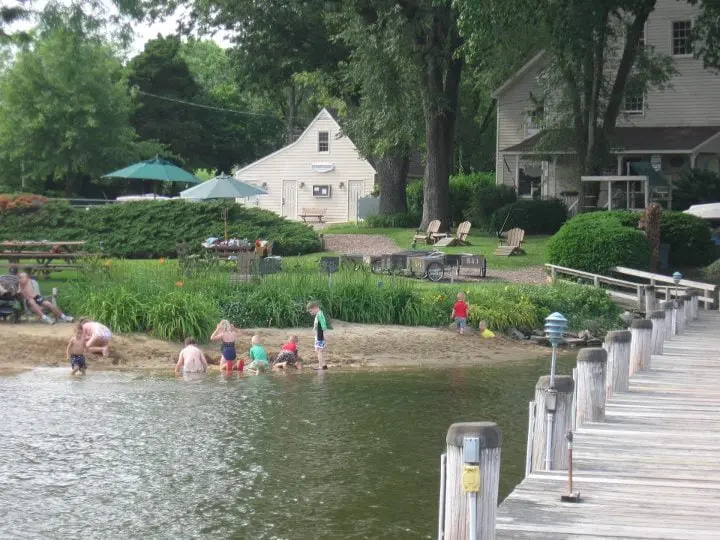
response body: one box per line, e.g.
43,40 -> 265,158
501,126 -> 720,154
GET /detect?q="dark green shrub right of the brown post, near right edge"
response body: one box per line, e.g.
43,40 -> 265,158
660,211 -> 716,268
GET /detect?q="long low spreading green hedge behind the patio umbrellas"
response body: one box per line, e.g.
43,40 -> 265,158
0,200 -> 320,259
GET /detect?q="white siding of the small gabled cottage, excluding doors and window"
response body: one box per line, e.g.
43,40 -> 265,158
235,110 -> 375,222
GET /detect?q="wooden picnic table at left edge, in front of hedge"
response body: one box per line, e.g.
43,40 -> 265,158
0,240 -> 92,278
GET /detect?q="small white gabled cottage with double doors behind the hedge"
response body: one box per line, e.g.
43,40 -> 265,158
234,109 -> 375,222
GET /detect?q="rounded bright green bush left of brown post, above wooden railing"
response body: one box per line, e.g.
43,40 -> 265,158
547,213 -> 650,274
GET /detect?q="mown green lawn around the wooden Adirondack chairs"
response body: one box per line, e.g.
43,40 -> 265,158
322,223 -> 550,270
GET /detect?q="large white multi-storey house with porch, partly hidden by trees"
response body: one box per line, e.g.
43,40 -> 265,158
493,0 -> 720,215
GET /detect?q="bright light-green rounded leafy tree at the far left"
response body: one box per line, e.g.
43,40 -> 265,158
0,27 -> 161,195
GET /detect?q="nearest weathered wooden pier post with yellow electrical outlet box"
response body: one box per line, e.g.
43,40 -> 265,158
443,422 -> 502,540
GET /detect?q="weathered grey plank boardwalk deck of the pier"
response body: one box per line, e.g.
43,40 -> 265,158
497,310 -> 720,540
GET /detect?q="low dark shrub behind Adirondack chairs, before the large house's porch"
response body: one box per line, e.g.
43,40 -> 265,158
490,199 -> 567,234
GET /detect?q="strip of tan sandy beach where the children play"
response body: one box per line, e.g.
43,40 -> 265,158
0,321 -> 547,373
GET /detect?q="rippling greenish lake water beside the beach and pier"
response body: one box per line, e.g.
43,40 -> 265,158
0,359 -> 570,540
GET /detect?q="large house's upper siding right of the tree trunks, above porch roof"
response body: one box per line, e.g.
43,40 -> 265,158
618,0 -> 720,127
